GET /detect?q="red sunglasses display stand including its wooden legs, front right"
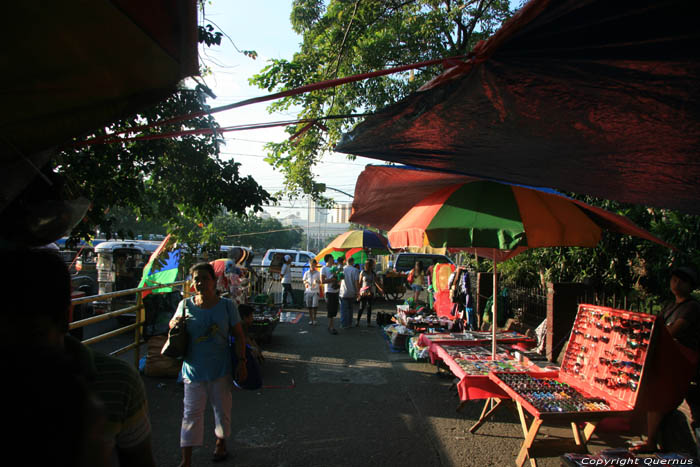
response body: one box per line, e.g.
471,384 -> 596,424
485,304 -> 656,466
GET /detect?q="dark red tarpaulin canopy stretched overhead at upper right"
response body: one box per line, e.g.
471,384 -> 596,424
337,0 -> 700,214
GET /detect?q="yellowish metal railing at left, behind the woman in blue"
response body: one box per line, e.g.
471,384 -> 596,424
68,281 -> 189,368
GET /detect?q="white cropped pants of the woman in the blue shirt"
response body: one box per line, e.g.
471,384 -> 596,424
180,375 -> 233,448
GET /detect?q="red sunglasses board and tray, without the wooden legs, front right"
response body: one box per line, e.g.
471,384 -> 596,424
489,305 -> 656,417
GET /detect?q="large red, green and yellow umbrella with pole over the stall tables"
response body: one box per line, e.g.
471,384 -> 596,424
388,180 -> 671,355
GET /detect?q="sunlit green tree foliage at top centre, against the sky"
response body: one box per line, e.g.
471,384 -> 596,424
250,0 -> 512,199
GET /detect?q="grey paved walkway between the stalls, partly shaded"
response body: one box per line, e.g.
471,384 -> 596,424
90,302 -> 644,467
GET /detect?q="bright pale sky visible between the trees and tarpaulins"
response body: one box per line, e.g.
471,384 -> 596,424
191,0 -> 381,218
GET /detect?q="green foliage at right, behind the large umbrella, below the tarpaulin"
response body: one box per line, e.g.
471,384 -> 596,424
499,194 -> 700,308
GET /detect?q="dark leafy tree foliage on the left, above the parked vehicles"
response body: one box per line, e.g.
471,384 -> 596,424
56,89 -> 270,247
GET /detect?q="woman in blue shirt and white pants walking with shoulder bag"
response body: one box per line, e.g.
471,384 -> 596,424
170,263 -> 248,467
